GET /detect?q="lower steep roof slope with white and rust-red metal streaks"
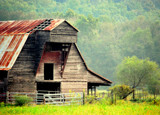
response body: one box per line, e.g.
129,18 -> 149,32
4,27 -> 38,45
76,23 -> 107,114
0,33 -> 29,70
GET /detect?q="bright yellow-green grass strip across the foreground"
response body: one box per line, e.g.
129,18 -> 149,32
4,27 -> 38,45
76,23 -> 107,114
0,102 -> 160,115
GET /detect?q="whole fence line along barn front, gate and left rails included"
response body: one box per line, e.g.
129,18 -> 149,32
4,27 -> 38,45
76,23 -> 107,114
0,91 -> 83,105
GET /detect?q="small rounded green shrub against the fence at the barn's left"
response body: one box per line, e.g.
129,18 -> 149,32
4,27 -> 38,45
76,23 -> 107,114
15,95 -> 33,106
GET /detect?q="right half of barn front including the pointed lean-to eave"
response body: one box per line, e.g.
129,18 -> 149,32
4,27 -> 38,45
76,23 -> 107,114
61,44 -> 110,92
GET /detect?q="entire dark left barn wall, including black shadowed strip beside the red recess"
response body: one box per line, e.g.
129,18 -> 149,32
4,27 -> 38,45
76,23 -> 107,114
8,31 -> 49,92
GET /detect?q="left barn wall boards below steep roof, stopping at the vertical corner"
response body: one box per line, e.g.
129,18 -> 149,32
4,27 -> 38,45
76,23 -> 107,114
8,35 -> 36,92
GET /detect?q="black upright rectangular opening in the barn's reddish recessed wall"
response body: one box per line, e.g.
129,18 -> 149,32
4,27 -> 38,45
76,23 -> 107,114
44,63 -> 54,80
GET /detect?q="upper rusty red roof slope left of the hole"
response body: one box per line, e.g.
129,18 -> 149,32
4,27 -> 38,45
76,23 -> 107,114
0,19 -> 45,35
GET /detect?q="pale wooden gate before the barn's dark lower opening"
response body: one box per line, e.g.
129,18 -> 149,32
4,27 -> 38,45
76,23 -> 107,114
44,92 -> 83,105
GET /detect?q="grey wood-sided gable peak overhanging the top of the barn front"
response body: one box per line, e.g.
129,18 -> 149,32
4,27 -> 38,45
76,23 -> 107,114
50,22 -> 77,43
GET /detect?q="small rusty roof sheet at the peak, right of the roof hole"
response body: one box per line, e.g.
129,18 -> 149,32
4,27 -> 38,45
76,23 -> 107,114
44,19 -> 65,30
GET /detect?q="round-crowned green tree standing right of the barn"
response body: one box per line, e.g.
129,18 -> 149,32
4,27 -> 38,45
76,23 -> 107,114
117,56 -> 159,98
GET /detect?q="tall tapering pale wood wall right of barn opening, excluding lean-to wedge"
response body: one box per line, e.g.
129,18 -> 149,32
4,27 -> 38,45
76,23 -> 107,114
61,44 -> 87,93
